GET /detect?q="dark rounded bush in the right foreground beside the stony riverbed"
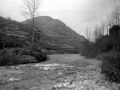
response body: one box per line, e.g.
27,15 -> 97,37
101,52 -> 120,83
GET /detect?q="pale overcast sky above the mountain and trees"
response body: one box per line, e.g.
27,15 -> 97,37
0,0 -> 120,36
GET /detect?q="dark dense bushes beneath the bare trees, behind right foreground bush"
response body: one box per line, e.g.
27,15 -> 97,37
81,25 -> 120,58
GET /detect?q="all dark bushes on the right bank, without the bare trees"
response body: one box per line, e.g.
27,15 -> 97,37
81,26 -> 120,83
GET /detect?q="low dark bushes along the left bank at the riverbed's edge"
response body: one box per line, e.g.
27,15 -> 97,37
0,48 -> 47,66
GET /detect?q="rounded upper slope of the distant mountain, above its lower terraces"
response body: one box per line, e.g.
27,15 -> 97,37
22,16 -> 85,41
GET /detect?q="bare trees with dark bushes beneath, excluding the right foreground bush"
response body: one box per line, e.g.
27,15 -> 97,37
81,6 -> 120,57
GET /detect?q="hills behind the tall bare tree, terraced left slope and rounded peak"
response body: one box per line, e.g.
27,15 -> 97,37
0,16 -> 85,53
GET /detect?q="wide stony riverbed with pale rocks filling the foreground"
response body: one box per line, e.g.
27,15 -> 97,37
0,54 -> 118,90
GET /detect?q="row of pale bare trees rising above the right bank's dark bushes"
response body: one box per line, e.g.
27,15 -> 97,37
85,6 -> 120,41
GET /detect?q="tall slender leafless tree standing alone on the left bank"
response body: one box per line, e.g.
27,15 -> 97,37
22,0 -> 40,43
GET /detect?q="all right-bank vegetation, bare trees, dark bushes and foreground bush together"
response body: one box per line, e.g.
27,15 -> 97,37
81,7 -> 120,83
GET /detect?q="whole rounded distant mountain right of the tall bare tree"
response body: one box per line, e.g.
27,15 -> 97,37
22,16 -> 85,48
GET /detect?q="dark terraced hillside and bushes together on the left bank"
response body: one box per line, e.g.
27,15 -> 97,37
0,17 -> 47,66
